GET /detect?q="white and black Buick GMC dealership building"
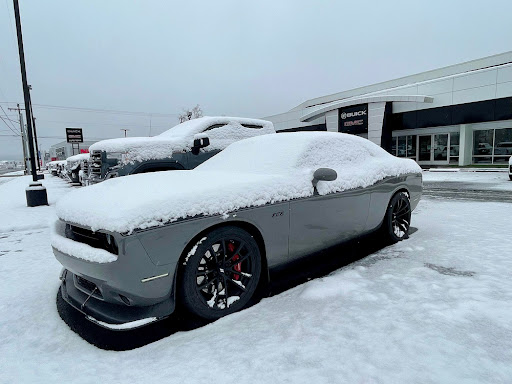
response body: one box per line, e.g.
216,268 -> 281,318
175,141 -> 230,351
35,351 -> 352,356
265,52 -> 512,165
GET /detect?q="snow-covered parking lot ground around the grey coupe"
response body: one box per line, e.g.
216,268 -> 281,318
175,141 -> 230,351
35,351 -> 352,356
0,175 -> 512,383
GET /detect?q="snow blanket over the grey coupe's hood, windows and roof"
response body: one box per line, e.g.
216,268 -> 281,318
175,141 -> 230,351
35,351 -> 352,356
57,132 -> 421,233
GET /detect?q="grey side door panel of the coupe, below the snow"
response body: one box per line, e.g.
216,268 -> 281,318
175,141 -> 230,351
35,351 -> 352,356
288,188 -> 370,259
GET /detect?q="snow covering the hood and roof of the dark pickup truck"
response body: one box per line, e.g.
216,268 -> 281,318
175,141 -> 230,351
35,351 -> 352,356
90,116 -> 275,163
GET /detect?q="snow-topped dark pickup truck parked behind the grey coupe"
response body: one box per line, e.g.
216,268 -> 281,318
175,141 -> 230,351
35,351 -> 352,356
87,116 -> 276,184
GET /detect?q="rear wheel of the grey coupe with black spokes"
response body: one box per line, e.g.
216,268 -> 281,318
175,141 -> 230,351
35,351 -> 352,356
383,192 -> 411,244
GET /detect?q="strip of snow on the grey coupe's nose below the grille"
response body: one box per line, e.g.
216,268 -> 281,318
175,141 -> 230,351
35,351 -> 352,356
51,220 -> 117,263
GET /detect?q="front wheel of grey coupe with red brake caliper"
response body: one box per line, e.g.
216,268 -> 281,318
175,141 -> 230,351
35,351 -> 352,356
178,226 -> 262,320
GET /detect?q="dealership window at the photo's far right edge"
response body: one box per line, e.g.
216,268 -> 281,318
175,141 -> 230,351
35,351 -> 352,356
473,128 -> 512,164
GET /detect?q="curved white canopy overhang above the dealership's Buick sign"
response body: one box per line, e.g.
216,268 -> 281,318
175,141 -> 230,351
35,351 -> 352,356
300,95 -> 434,122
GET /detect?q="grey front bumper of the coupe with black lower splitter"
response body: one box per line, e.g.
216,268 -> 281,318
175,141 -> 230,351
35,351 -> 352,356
53,230 -> 176,329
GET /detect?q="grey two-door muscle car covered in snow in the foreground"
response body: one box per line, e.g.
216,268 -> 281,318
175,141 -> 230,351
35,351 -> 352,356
52,132 -> 422,329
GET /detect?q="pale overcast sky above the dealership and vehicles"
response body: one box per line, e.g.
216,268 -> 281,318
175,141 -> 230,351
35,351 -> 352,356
0,0 -> 512,159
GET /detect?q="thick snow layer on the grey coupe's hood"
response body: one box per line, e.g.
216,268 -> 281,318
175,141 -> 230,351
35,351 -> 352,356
57,170 -> 313,233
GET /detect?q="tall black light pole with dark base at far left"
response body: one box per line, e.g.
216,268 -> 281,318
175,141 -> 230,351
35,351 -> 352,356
13,0 -> 48,207
